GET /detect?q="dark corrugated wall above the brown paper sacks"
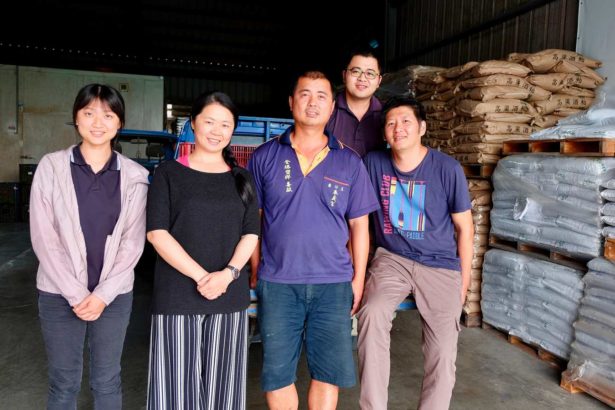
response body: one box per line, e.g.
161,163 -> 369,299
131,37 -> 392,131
385,0 -> 578,71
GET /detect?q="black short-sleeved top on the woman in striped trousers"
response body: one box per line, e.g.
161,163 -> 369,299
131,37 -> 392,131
147,161 -> 260,315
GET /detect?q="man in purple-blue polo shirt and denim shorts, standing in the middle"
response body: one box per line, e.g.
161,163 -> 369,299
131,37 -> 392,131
249,71 -> 379,409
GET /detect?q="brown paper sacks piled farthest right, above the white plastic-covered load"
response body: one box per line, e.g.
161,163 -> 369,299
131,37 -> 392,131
508,49 -> 604,128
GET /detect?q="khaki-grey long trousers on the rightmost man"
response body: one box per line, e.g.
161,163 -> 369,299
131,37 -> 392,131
357,248 -> 462,410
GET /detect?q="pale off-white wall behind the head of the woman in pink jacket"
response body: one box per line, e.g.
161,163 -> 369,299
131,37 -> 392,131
0,65 -> 164,182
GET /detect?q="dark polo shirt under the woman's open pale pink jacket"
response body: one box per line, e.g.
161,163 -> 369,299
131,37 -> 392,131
70,145 -> 122,292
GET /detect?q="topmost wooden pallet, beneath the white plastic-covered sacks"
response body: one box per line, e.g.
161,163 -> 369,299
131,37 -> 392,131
502,138 -> 615,157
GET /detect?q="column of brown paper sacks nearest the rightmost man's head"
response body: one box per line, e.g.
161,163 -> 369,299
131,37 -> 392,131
449,60 -> 551,164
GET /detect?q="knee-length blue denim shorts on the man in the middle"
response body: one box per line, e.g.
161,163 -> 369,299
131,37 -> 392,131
256,280 -> 356,391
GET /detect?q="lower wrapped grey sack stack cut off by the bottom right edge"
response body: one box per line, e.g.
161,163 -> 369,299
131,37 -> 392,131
568,258 -> 615,397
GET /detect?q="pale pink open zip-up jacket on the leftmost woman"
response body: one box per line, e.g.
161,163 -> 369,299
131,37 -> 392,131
30,147 -> 148,306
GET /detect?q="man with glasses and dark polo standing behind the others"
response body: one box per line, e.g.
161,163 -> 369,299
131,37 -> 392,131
326,51 -> 386,157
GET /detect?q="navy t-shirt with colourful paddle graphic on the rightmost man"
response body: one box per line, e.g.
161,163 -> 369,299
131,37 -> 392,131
365,148 -> 471,270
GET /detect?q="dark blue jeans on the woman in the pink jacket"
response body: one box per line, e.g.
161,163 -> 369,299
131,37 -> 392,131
38,292 -> 132,410
